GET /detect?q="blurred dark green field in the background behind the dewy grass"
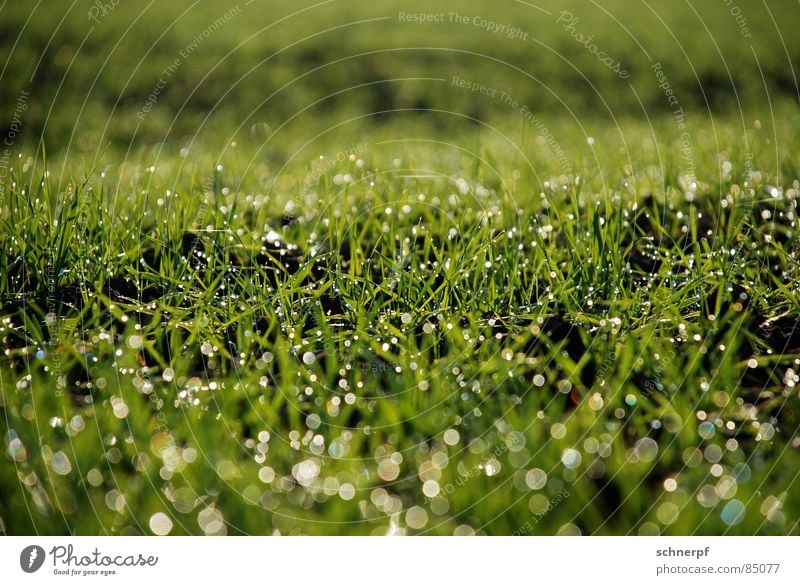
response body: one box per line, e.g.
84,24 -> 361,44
0,0 -> 800,154
